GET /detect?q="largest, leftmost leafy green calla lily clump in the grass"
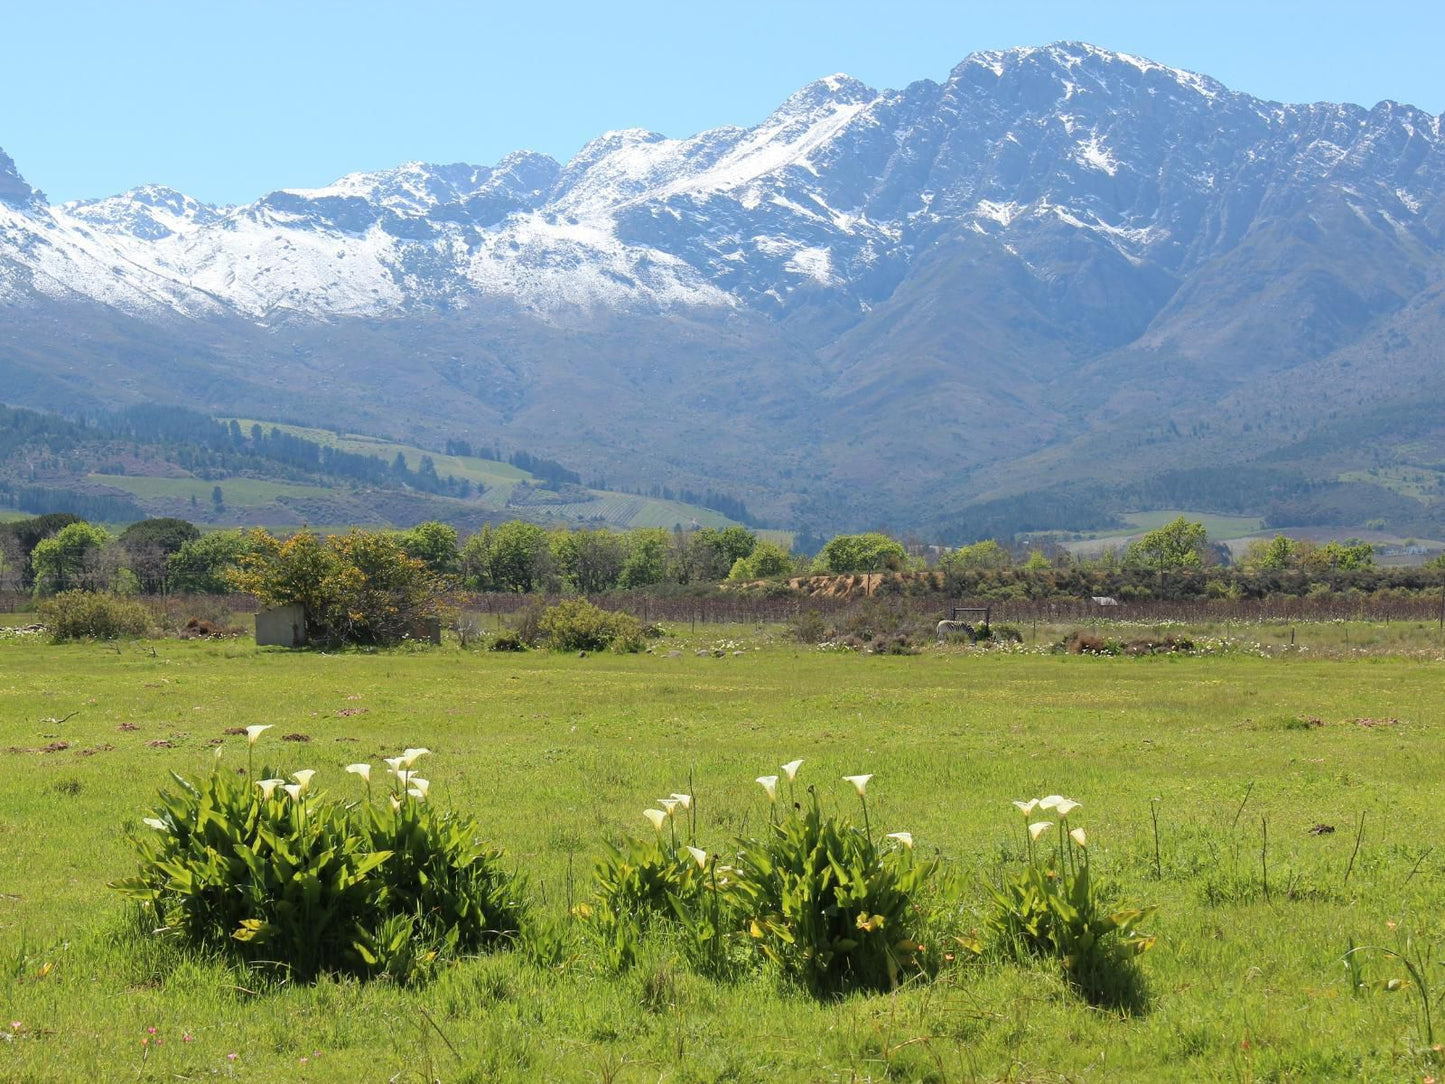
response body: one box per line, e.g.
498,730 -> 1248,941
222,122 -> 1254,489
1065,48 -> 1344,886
111,750 -> 520,983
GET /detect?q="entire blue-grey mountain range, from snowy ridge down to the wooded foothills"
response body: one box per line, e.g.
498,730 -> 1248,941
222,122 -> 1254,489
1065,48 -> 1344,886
0,43 -> 1445,533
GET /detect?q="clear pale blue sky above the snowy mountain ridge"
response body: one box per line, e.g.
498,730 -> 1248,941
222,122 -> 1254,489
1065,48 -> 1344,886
0,0 -> 1445,202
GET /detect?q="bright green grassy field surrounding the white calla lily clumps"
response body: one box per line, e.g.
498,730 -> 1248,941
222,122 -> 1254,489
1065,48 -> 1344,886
0,626 -> 1445,1083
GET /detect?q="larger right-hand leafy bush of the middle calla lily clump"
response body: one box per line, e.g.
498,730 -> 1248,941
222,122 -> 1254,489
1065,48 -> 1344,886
734,788 -> 938,993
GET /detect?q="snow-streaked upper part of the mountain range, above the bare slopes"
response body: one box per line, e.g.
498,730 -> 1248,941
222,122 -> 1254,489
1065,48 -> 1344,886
0,42 -> 1445,319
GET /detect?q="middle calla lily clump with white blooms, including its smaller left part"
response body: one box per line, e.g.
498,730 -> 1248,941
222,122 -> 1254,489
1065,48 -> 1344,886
578,759 -> 938,991
